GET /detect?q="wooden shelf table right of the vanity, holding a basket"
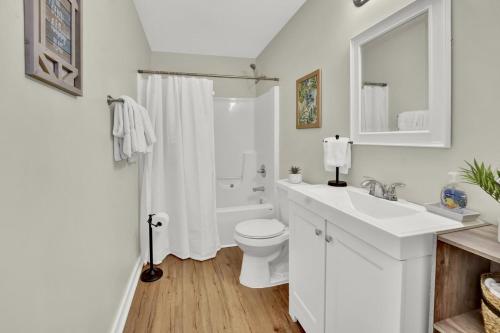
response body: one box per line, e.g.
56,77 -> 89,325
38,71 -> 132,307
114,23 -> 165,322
434,225 -> 500,333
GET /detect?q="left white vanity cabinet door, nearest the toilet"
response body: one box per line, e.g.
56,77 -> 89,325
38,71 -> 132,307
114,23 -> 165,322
290,203 -> 326,333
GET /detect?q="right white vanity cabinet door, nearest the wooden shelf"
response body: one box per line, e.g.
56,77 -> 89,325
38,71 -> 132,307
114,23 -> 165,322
325,223 -> 403,333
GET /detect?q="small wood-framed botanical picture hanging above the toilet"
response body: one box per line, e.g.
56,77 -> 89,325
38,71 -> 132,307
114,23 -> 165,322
296,69 -> 321,129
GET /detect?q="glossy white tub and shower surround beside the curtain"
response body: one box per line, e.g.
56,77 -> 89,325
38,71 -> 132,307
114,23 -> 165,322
214,87 -> 279,247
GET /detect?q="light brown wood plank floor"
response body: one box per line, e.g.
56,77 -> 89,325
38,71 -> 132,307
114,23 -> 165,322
125,247 -> 304,333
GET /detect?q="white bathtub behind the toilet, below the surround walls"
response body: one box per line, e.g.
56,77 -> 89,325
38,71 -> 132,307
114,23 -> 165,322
217,203 -> 275,247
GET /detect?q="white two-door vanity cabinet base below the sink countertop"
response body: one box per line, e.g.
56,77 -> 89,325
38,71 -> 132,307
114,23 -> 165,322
290,200 -> 431,333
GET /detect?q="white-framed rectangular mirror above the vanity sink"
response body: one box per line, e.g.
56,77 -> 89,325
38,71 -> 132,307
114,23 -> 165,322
351,0 -> 451,148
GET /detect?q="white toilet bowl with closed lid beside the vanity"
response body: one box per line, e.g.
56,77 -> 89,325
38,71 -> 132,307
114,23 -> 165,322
234,219 -> 289,288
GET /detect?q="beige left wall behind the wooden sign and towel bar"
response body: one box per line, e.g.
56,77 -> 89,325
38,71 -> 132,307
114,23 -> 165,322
0,0 -> 150,333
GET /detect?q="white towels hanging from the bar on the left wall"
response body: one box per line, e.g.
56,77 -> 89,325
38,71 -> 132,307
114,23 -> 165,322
113,96 -> 156,162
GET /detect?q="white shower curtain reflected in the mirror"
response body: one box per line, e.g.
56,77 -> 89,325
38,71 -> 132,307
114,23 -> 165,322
361,85 -> 389,132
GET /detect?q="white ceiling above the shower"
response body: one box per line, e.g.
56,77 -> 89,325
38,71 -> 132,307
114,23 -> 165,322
134,0 -> 306,58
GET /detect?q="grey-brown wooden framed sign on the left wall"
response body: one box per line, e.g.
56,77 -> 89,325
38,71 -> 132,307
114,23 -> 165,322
24,0 -> 82,96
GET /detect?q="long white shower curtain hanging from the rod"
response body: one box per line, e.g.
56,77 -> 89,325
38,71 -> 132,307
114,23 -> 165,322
138,75 -> 220,264
